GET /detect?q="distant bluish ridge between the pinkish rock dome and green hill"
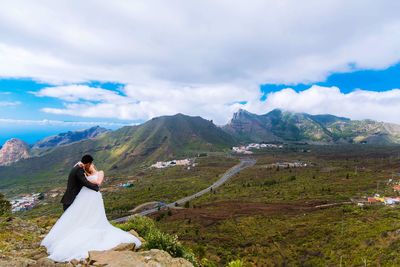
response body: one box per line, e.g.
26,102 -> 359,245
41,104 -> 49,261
33,126 -> 109,149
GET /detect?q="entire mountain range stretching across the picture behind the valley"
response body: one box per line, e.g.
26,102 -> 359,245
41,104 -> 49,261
0,110 -> 400,189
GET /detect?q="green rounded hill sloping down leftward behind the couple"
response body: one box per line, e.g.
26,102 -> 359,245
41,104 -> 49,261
0,114 -> 235,195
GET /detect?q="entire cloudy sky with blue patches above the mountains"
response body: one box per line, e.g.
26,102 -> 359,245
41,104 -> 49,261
0,0 -> 400,144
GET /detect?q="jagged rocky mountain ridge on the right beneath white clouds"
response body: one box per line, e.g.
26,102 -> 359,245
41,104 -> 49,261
223,109 -> 400,144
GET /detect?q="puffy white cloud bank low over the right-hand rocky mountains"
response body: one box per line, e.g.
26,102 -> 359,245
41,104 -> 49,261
254,85 -> 400,124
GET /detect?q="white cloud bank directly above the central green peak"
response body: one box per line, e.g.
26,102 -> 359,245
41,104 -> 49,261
35,82 -> 261,124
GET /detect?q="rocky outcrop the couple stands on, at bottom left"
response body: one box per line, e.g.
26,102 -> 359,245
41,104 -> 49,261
0,217 -> 193,267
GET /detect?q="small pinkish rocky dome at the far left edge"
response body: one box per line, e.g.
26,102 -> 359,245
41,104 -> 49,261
0,138 -> 29,166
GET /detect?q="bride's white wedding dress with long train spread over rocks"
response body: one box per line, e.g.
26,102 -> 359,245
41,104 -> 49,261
41,175 -> 141,262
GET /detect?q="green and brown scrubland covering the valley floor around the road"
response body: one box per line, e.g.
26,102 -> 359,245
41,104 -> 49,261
4,145 -> 400,266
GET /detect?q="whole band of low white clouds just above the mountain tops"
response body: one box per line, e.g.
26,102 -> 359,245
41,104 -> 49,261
36,83 -> 400,124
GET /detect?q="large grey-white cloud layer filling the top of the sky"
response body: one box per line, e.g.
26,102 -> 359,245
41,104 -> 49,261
0,0 -> 400,84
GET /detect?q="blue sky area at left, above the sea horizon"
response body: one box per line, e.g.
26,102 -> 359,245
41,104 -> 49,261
0,81 -> 133,144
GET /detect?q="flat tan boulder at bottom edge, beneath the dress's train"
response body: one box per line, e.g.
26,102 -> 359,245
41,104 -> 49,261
89,249 -> 193,267
